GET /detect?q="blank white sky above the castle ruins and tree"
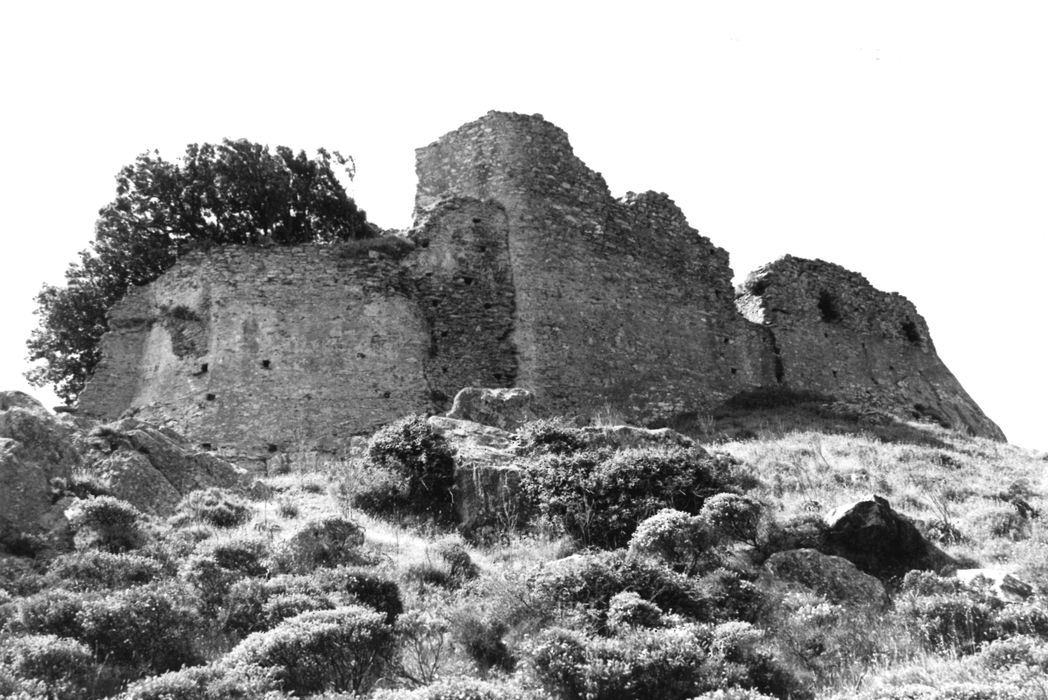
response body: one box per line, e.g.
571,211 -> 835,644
0,0 -> 1048,449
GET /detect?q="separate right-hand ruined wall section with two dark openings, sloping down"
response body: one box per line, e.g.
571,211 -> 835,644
737,256 -> 1004,439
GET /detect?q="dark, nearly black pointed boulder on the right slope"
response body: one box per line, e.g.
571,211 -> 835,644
826,496 -> 956,581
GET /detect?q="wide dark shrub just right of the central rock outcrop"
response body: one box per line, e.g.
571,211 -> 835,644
521,447 -> 727,548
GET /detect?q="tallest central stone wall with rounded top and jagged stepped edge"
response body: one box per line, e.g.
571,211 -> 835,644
417,114 -> 773,422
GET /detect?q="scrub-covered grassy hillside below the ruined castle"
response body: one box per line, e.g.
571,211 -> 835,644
0,412 -> 1048,700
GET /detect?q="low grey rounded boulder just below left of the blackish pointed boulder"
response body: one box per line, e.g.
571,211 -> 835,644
761,549 -> 888,609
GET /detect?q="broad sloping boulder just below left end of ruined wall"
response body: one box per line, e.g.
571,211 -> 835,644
85,418 -> 265,516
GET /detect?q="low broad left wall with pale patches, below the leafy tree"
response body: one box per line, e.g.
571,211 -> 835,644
80,246 -> 430,454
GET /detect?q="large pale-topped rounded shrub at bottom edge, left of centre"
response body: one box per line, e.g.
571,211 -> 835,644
225,606 -> 395,695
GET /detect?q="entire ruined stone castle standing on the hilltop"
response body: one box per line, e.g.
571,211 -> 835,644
80,112 -> 1003,455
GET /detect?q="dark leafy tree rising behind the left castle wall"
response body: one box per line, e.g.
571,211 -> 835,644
26,139 -> 374,402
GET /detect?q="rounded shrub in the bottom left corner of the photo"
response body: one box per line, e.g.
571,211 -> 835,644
0,634 -> 96,699
